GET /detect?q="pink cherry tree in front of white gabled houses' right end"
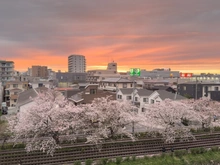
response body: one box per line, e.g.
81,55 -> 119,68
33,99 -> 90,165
142,99 -> 198,143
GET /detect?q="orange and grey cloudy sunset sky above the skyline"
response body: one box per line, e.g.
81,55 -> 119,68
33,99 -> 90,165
0,0 -> 220,73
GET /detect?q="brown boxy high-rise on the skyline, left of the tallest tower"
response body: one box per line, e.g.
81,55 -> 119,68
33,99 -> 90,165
31,66 -> 48,78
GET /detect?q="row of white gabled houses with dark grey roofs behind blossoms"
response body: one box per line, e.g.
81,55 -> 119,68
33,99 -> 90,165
116,88 -> 186,113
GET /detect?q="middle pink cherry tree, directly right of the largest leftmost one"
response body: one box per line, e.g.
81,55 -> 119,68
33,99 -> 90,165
78,97 -> 138,144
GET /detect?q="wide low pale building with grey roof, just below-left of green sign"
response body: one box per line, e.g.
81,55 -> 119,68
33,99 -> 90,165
99,78 -> 135,91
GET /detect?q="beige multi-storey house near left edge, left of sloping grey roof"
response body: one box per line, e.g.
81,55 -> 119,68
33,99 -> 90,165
4,81 -> 29,107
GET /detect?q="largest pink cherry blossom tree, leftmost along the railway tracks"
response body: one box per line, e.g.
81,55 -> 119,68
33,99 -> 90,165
9,90 -> 82,154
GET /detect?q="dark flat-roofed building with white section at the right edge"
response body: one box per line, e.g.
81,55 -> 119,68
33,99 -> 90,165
178,81 -> 220,101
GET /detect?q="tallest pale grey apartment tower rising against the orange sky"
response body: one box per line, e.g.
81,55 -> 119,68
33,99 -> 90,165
68,55 -> 86,73
